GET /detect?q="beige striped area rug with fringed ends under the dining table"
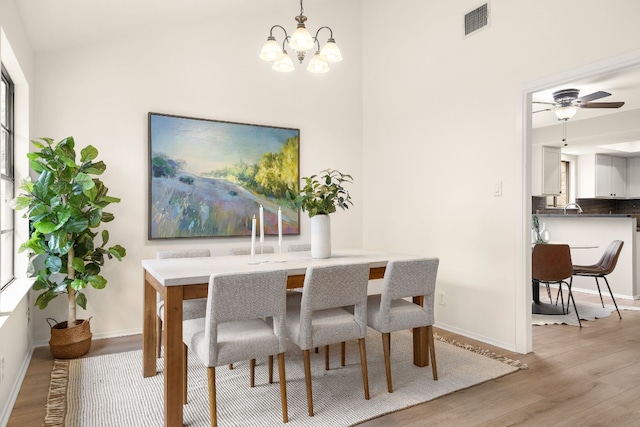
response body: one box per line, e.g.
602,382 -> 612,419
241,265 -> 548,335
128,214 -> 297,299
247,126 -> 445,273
44,331 -> 527,427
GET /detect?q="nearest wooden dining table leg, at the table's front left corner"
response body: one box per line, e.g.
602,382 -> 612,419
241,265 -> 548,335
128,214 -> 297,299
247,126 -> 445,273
165,286 -> 184,427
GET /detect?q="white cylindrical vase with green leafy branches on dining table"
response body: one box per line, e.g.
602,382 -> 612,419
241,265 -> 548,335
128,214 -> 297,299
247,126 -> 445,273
287,169 -> 353,258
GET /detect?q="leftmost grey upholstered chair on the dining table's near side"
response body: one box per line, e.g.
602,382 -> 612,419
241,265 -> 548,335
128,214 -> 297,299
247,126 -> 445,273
183,270 -> 289,426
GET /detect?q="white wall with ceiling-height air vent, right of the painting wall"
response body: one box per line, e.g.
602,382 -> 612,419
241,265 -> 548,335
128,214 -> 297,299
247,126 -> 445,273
363,0 -> 640,351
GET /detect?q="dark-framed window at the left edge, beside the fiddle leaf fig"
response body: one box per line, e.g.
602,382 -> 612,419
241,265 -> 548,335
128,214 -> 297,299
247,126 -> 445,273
0,66 -> 15,290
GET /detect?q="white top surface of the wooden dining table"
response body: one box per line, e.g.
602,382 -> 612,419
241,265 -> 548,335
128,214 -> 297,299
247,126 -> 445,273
142,249 -> 425,286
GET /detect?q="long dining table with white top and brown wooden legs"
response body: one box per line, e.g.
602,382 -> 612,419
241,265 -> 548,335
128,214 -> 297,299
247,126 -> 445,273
142,249 -> 429,426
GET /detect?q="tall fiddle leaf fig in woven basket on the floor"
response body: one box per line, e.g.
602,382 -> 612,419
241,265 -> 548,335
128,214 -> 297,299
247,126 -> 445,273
14,137 -> 126,358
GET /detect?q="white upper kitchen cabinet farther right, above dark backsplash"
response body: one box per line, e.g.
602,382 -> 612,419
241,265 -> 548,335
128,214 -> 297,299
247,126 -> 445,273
577,154 -> 627,198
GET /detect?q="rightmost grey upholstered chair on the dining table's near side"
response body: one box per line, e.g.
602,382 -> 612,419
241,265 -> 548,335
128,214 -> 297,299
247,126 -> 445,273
367,258 -> 440,393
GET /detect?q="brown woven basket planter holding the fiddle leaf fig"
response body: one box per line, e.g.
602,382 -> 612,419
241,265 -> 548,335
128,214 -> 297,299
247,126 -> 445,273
49,319 -> 93,359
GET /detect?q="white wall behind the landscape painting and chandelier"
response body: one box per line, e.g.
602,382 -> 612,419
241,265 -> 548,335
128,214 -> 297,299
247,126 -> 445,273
32,0 -> 365,344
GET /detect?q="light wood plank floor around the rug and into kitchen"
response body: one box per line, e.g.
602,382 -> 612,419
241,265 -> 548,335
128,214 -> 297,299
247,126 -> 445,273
8,292 -> 640,427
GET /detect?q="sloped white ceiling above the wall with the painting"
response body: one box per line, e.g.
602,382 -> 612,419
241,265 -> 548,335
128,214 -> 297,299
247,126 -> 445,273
16,0 -> 304,53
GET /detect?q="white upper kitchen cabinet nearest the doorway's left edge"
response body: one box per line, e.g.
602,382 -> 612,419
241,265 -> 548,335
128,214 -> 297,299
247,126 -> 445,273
531,145 -> 561,196
